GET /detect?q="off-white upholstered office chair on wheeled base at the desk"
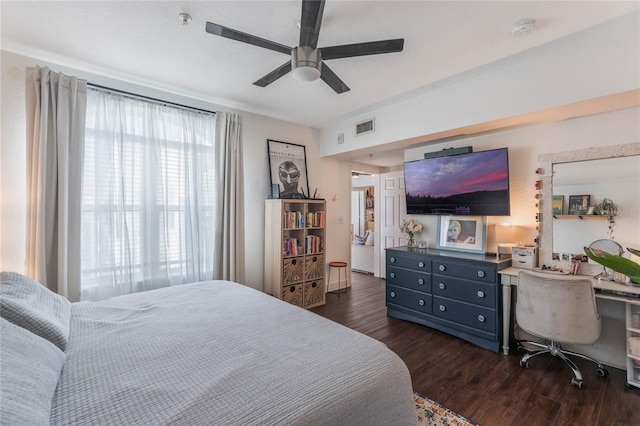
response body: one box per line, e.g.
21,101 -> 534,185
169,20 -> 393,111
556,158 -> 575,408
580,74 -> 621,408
516,270 -> 609,388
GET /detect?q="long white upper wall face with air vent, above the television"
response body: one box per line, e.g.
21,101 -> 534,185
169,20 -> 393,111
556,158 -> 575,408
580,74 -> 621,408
320,13 -> 640,161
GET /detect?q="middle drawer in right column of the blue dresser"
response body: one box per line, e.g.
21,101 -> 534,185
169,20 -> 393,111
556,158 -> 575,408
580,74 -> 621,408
432,275 -> 496,308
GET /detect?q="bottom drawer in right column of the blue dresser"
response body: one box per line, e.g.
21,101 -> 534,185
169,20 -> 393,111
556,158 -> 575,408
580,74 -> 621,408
433,296 -> 496,334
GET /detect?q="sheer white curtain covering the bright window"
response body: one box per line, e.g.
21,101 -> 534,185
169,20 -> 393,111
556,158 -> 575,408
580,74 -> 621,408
82,87 -> 220,300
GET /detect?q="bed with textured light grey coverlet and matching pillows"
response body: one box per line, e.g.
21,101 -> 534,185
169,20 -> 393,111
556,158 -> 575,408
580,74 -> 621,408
0,272 -> 417,425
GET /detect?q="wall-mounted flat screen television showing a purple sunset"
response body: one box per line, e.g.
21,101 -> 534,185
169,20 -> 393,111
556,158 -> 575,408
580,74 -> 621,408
404,148 -> 510,216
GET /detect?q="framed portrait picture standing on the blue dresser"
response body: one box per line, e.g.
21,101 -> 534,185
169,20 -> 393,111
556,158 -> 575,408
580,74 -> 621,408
436,216 -> 487,254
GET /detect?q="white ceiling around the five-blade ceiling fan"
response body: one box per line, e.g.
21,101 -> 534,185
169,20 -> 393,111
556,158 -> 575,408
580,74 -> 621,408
0,0 -> 640,131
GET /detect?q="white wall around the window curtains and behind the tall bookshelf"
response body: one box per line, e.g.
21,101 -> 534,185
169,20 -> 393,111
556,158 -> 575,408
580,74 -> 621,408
0,51 -> 350,290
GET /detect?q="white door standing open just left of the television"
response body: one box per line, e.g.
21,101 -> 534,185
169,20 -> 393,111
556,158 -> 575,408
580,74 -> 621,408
376,171 -> 407,277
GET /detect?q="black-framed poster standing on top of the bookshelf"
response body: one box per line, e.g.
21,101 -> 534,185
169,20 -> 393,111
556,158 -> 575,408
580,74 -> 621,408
267,139 -> 309,198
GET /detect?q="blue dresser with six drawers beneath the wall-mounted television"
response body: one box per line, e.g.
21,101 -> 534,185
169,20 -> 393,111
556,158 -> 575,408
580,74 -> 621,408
386,247 -> 511,352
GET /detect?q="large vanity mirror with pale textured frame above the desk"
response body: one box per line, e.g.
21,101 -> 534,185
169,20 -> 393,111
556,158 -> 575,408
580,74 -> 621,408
539,143 -> 640,264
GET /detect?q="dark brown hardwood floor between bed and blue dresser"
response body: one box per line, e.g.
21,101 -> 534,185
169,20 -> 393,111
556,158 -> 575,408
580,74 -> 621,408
312,272 -> 640,426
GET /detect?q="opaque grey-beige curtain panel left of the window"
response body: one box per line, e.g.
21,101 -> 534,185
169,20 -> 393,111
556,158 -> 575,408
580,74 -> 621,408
25,67 -> 87,301
